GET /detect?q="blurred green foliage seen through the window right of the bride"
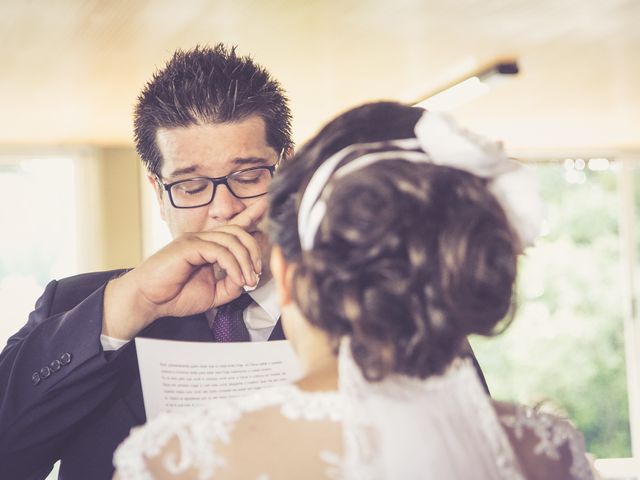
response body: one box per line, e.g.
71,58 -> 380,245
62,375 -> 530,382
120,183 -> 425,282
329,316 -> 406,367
471,165 -> 631,458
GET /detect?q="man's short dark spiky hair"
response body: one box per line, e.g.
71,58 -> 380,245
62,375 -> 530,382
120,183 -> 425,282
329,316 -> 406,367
134,44 -> 292,176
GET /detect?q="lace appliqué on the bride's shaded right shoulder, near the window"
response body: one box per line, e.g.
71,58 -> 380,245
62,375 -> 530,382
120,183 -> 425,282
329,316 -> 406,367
500,405 -> 593,479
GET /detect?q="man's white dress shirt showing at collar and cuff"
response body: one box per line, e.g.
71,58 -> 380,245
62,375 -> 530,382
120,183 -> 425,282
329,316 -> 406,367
100,278 -> 280,352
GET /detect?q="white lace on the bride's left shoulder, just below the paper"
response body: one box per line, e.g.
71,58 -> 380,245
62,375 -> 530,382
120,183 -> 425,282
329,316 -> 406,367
114,385 -> 342,480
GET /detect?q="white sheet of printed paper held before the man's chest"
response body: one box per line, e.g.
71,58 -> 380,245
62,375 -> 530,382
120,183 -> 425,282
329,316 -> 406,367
135,338 -> 301,419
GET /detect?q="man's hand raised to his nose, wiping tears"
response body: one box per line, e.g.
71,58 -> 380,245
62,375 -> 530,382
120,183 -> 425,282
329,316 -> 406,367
102,199 -> 267,340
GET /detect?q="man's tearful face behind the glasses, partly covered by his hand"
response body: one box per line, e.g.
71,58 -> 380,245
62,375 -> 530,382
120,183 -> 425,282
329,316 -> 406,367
150,116 -> 279,278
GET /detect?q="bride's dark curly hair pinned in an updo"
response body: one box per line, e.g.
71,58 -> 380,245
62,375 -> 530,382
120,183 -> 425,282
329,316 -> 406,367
269,102 -> 518,380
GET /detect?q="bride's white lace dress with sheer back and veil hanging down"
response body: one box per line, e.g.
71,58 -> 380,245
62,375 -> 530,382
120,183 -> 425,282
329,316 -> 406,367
114,348 -> 593,480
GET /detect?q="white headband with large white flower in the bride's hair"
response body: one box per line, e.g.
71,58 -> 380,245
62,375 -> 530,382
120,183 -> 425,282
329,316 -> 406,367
298,111 -> 544,251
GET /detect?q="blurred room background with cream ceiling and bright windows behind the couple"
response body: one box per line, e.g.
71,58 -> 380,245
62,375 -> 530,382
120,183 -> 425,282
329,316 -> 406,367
0,0 -> 640,479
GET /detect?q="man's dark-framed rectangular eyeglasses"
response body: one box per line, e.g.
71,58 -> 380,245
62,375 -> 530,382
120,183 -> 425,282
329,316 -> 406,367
156,163 -> 280,208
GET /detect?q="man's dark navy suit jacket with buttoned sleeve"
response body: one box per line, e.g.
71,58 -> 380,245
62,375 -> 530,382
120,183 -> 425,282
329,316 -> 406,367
0,271 -> 284,480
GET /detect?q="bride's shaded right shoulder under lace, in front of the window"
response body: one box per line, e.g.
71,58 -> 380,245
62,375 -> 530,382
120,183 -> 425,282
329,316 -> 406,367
493,401 -> 594,480
